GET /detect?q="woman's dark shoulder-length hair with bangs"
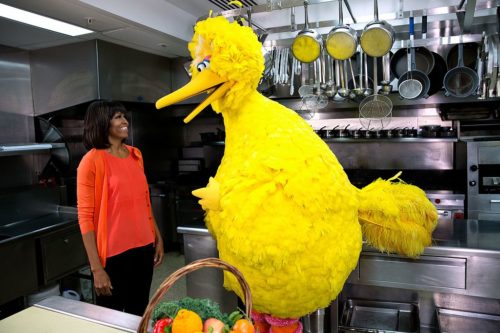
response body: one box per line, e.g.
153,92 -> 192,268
83,101 -> 127,150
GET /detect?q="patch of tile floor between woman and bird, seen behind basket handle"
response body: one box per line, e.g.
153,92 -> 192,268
149,252 -> 186,300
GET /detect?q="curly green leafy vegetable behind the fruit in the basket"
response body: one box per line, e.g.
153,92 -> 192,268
152,297 -> 228,323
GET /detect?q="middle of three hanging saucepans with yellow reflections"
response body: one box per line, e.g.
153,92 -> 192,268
326,0 -> 358,60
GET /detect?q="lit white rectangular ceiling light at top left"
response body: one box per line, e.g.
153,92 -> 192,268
0,4 -> 93,36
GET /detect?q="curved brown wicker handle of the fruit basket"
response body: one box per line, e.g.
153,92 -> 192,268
137,258 -> 252,333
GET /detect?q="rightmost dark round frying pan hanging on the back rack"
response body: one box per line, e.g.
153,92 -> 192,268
443,35 -> 479,97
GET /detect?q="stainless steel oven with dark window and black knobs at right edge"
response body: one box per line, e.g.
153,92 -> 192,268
467,141 -> 500,221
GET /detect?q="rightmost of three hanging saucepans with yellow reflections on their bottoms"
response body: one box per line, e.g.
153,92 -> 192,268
360,0 -> 395,57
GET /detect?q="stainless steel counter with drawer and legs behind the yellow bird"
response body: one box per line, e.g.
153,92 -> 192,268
177,220 -> 500,332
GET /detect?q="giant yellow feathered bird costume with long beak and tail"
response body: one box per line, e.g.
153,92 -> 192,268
156,16 -> 437,333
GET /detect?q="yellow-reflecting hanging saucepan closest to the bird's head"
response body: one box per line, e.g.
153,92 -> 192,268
292,1 -> 323,63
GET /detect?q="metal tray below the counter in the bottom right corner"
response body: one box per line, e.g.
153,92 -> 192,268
436,308 -> 500,333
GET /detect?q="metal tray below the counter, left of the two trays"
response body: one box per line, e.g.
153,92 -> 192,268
339,299 -> 420,333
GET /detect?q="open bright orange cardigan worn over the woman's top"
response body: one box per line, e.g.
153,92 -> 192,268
76,146 -> 155,267
